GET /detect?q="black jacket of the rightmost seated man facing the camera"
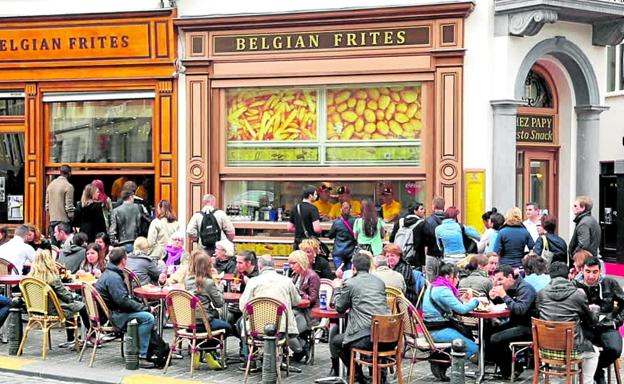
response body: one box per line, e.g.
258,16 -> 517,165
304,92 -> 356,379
574,276 -> 624,329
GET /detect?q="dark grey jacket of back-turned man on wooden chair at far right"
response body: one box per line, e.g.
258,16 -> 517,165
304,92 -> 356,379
536,277 -> 597,352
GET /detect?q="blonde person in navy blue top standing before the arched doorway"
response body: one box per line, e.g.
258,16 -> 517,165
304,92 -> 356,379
494,207 -> 535,268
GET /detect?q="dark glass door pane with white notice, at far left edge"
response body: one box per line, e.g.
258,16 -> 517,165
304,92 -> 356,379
0,133 -> 24,224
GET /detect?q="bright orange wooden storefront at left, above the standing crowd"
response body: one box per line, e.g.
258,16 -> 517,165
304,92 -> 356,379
0,9 -> 178,228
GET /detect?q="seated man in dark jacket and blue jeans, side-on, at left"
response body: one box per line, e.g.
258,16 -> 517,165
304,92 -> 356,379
95,247 -> 154,367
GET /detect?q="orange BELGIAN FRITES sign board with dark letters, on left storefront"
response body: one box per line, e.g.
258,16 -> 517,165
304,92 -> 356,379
0,24 -> 149,62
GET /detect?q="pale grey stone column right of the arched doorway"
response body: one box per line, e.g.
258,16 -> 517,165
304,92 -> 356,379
573,105 -> 609,219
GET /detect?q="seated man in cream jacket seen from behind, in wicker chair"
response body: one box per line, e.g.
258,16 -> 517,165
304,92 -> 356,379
239,255 -> 303,360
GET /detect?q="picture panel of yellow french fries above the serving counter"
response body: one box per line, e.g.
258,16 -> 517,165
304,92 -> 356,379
226,88 -> 317,142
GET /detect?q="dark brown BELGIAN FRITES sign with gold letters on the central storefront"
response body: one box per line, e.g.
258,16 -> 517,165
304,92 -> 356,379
213,26 -> 430,54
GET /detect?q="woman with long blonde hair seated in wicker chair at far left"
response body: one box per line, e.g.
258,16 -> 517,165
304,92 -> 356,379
28,249 -> 91,348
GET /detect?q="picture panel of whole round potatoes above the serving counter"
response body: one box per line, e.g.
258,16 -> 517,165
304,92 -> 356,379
327,85 -> 422,141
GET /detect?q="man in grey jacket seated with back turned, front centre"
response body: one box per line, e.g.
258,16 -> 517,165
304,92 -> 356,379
330,252 -> 394,383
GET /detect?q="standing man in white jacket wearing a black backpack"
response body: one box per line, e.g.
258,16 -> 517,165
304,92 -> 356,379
186,194 -> 235,255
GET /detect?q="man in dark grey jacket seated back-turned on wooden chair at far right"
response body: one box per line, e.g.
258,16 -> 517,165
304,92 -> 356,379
536,261 -> 604,384
